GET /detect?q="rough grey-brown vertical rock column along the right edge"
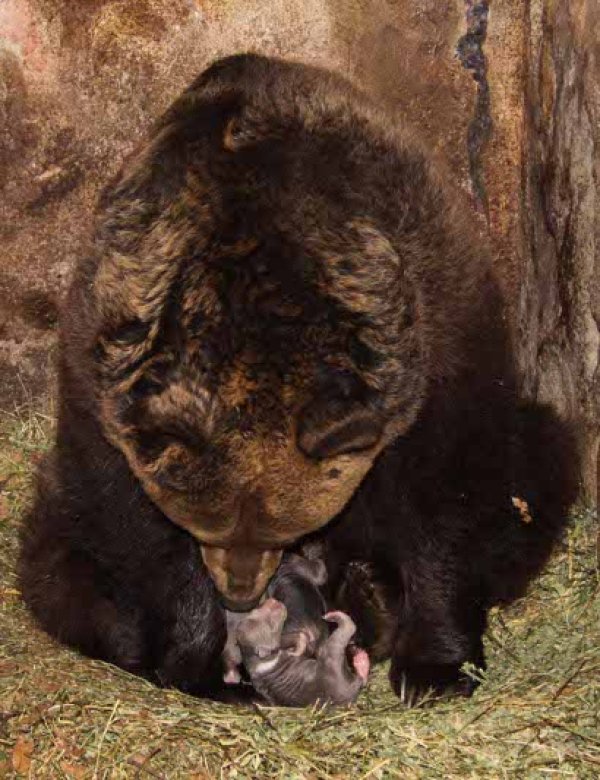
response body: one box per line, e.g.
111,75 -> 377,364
518,0 -> 600,501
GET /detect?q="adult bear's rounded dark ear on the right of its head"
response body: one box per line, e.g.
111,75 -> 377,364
296,399 -> 384,460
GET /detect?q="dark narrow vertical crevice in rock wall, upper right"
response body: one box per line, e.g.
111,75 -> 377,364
456,0 -> 492,218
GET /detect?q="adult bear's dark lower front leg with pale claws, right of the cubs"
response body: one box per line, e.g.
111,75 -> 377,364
390,548 -> 486,706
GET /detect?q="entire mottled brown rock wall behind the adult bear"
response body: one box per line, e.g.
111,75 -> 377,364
0,0 -> 600,498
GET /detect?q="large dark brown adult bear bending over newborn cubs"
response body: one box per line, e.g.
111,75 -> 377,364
21,55 -> 577,700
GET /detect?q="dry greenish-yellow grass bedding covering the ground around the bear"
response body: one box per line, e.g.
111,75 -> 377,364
0,412 -> 600,780
